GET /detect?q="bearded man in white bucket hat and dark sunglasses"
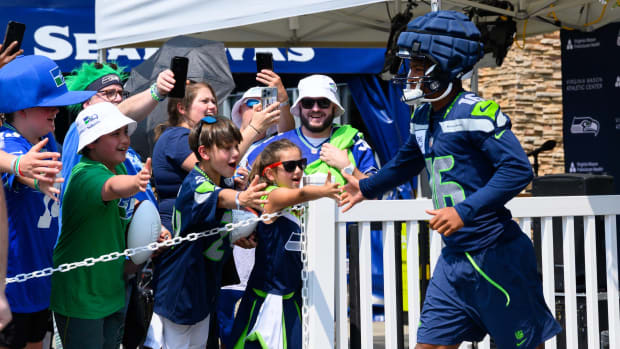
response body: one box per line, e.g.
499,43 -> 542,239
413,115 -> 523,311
242,75 -> 377,184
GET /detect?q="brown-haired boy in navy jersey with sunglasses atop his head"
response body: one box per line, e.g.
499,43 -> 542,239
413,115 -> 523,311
154,116 -> 266,348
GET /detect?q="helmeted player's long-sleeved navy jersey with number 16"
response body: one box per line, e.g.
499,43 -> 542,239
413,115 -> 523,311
360,92 -> 533,251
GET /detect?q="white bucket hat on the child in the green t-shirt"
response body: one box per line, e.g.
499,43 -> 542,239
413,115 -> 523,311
75,102 -> 138,153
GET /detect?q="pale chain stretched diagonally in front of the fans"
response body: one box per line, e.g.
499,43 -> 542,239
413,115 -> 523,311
6,206 -> 284,284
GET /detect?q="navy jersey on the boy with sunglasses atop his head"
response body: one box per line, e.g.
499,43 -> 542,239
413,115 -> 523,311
154,166 -> 232,325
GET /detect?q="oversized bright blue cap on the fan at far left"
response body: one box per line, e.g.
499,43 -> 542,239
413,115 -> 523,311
0,55 -> 97,113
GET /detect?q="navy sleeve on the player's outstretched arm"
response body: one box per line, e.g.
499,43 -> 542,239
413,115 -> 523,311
359,129 -> 424,198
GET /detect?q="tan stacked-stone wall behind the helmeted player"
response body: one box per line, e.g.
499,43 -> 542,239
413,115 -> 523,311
464,31 -> 564,175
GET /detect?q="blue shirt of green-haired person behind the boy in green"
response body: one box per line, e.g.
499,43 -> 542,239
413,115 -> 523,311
60,122 -> 157,207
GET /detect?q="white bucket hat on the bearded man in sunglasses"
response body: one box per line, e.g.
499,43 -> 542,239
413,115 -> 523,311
291,75 -> 344,117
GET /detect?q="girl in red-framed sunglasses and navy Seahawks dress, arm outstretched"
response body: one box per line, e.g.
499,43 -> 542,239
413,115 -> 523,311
233,139 -> 340,348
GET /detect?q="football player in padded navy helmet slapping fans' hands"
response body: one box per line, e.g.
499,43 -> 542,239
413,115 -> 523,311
342,11 -> 561,348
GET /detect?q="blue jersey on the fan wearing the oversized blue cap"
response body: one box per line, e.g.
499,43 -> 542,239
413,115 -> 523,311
0,123 -> 60,313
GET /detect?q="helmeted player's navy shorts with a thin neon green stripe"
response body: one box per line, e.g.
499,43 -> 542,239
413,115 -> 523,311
418,234 -> 562,349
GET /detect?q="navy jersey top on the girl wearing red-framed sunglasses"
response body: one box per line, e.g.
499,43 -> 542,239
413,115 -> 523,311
247,194 -> 302,295
